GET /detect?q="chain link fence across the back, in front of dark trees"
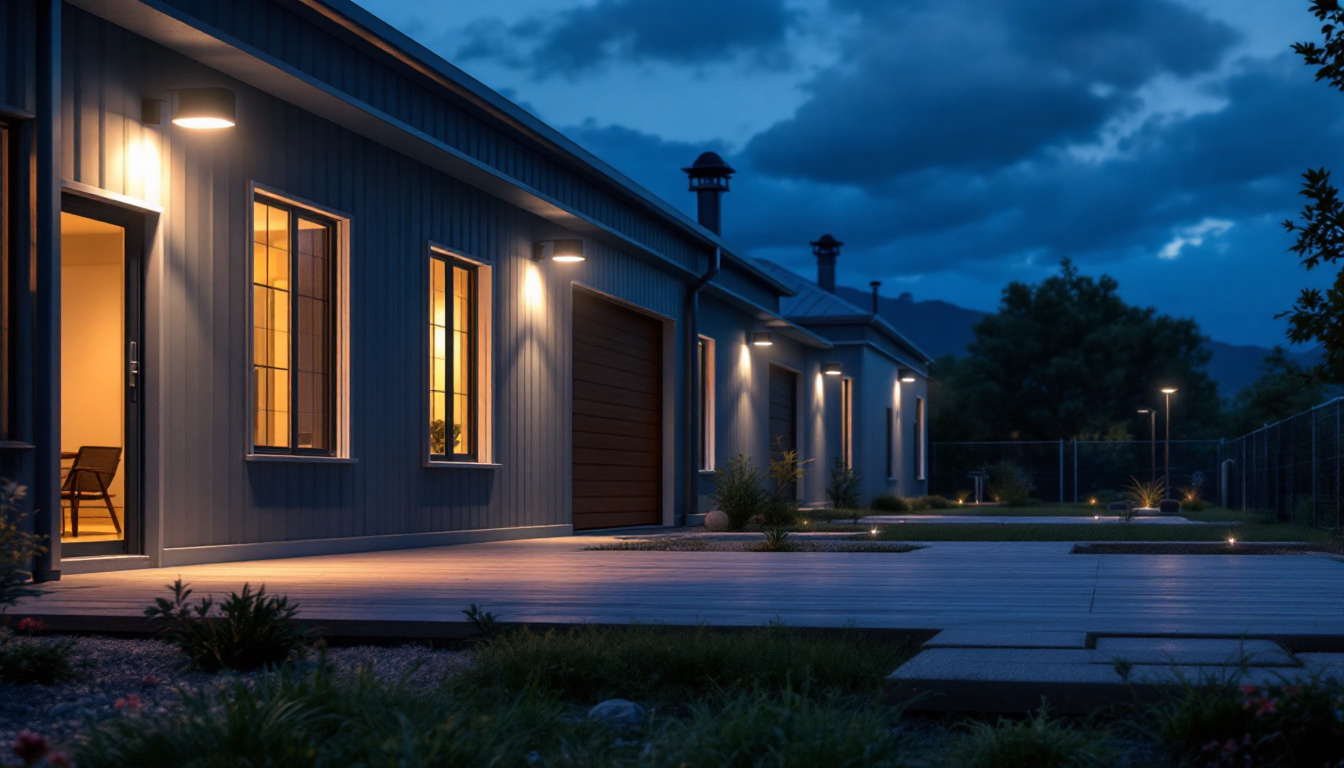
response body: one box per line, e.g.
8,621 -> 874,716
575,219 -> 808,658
929,440 -> 1223,503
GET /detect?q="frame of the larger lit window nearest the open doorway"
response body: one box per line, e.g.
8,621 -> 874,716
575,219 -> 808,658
246,184 -> 349,461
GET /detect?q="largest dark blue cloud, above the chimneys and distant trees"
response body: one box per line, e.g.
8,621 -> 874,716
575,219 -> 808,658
747,0 -> 1236,187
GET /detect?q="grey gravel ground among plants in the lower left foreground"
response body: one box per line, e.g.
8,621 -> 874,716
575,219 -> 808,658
0,636 -> 468,765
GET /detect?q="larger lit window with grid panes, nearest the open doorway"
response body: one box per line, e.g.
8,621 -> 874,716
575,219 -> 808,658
253,199 -> 336,455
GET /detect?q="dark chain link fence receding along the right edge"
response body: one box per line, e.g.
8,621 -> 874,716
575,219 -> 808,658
1223,398 -> 1344,530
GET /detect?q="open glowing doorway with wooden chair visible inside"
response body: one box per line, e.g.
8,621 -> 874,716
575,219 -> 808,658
60,200 -> 140,557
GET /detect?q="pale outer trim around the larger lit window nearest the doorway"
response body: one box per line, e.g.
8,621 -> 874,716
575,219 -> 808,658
244,182 -> 352,462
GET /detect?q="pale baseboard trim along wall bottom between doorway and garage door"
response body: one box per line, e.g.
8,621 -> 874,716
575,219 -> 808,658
163,525 -> 574,568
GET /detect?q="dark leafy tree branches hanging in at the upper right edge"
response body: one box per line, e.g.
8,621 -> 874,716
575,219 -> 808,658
1278,0 -> 1344,382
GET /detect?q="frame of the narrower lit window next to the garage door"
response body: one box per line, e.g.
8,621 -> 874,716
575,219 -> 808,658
421,247 -> 485,464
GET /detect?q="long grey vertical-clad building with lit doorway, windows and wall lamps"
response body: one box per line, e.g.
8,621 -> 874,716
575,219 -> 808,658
0,0 -> 924,578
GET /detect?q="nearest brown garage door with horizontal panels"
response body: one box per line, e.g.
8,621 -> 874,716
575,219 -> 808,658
574,289 -> 663,530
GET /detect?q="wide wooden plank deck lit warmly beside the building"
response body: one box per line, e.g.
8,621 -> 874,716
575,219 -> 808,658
11,537 -> 1344,638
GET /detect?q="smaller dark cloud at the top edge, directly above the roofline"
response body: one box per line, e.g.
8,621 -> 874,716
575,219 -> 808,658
457,0 -> 797,77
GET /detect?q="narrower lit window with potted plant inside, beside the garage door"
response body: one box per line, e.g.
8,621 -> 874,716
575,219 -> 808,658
429,252 -> 478,460
